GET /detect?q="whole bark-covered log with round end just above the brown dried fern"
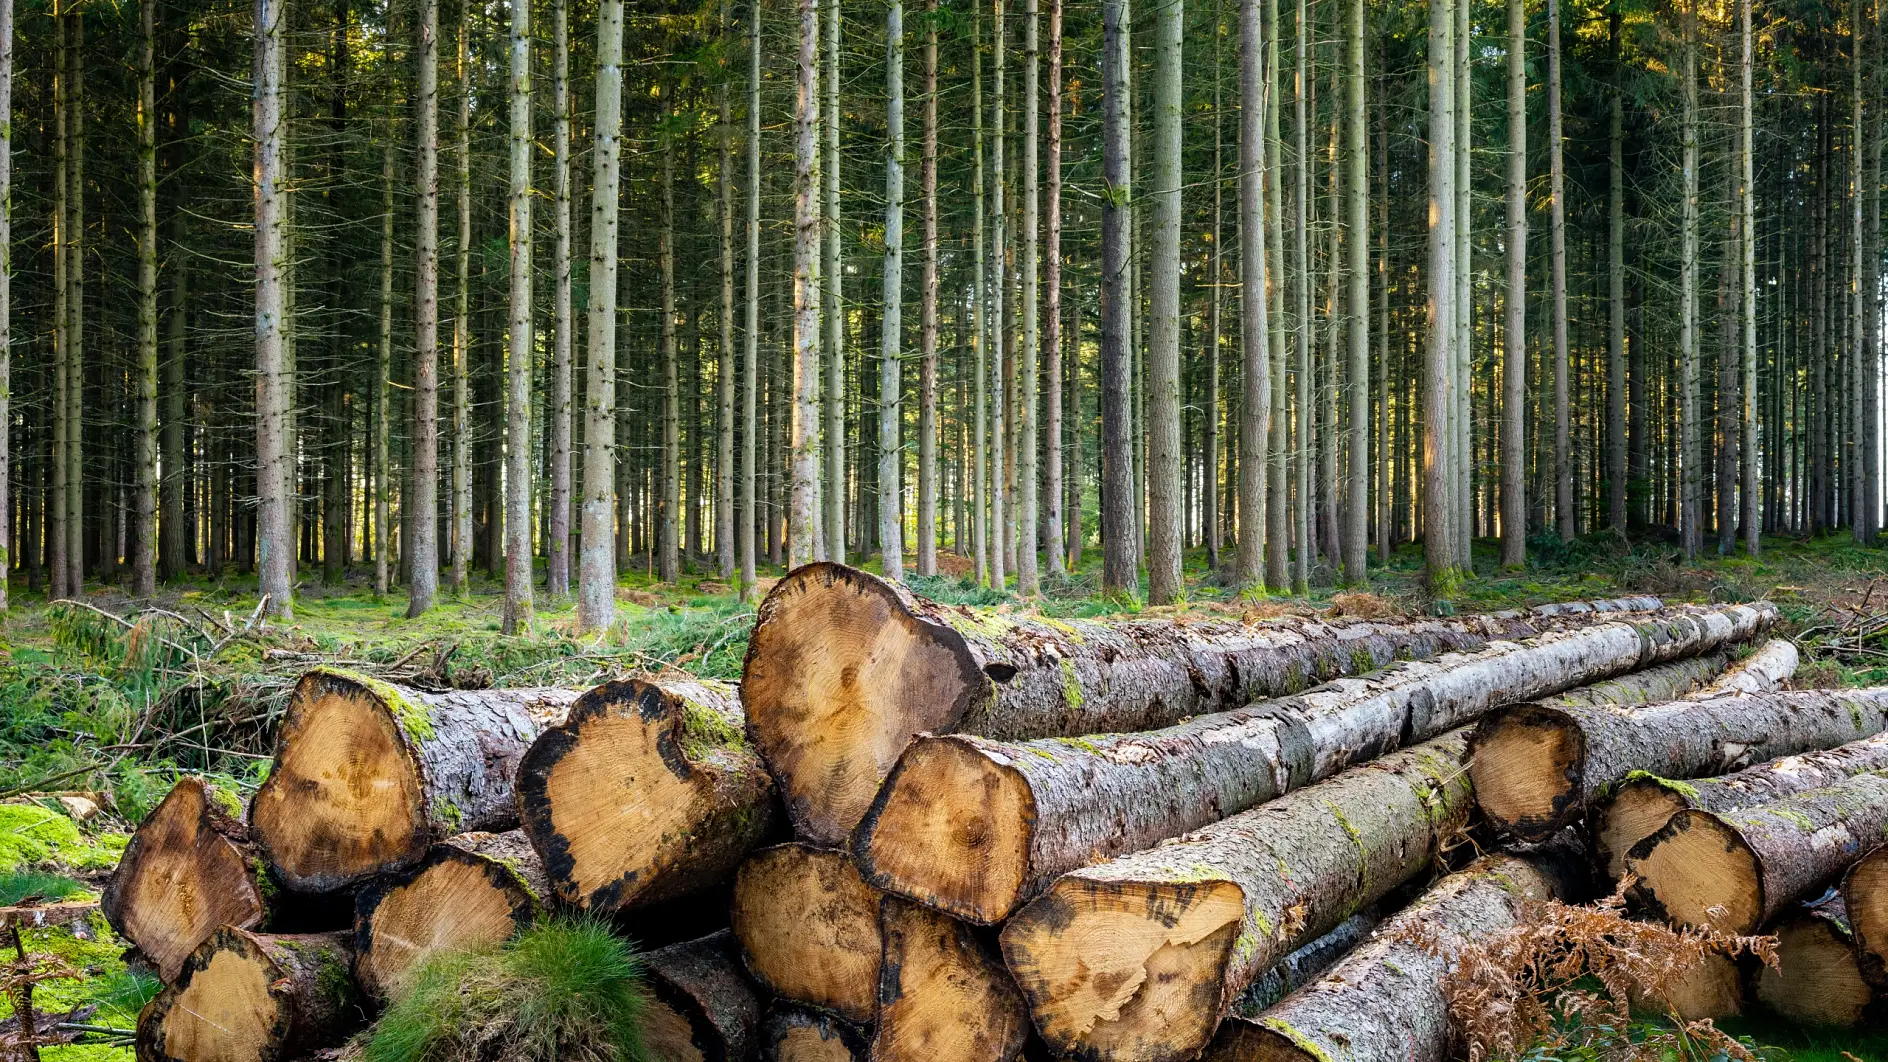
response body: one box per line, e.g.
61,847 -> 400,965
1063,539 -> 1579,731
1626,773 -> 1888,935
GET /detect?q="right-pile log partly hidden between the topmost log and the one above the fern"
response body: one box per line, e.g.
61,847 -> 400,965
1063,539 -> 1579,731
1593,721 -> 1888,881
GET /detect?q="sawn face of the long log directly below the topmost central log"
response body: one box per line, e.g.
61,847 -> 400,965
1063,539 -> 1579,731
853,737 -> 1037,926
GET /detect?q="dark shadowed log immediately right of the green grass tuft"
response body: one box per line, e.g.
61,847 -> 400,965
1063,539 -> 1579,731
642,930 -> 761,1062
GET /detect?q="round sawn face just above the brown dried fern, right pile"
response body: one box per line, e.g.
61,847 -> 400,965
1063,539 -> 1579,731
1626,809 -> 1765,934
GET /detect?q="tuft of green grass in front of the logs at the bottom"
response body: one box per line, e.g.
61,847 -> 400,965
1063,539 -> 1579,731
364,918 -> 648,1062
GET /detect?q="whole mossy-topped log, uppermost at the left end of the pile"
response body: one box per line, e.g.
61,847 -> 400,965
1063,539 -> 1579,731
249,669 -> 578,892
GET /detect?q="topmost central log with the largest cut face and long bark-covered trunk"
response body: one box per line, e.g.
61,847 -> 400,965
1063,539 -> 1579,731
742,563 -> 1658,845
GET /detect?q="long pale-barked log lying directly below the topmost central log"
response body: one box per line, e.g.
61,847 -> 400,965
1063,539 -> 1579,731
853,605 -> 1775,924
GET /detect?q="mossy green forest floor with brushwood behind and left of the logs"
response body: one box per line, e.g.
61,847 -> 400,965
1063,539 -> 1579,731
0,535 -> 1888,1062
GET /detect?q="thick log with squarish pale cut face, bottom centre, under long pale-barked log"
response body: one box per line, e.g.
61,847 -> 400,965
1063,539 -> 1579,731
1003,731 -> 1473,1062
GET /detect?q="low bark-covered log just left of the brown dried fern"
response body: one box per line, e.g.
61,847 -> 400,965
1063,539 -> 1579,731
1205,854 -> 1561,1062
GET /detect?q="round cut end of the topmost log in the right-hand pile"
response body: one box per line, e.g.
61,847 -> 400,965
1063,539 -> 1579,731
1469,705 -> 1586,841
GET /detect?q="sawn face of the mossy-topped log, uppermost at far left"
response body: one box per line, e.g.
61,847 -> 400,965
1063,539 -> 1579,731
249,671 -> 430,892
